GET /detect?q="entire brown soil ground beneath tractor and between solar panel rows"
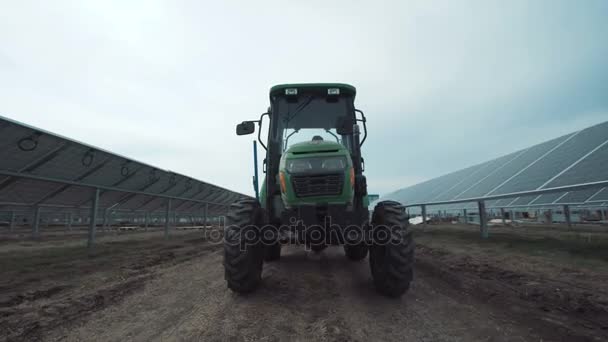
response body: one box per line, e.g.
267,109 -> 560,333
0,226 -> 608,341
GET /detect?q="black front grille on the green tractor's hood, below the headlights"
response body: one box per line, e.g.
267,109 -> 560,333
291,173 -> 344,197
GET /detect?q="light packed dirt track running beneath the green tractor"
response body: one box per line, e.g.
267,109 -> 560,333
49,247 -> 540,341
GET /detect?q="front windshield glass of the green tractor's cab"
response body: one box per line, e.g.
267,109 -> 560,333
272,94 -> 353,151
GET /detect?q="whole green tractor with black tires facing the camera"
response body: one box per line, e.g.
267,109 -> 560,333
224,83 -> 414,297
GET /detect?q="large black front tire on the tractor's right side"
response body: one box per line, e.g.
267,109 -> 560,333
369,201 -> 414,297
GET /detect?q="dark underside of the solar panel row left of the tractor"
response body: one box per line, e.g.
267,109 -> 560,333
0,116 -> 246,214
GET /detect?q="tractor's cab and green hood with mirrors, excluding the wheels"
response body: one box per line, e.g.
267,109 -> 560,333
237,83 -> 368,223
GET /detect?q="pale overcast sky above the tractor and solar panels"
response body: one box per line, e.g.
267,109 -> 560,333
0,0 -> 608,194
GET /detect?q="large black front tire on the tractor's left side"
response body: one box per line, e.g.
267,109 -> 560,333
224,199 -> 264,293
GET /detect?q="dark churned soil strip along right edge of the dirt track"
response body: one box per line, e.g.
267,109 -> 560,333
417,246 -> 608,341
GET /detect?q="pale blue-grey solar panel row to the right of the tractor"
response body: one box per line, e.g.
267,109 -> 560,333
385,122 -> 608,209
